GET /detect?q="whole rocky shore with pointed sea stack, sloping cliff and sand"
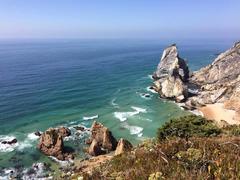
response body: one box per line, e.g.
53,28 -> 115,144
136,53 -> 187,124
152,42 -> 240,126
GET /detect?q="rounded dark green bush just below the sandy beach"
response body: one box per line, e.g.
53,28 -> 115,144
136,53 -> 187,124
157,115 -> 221,141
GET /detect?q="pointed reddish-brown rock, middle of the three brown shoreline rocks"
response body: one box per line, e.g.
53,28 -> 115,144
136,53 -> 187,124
87,121 -> 117,154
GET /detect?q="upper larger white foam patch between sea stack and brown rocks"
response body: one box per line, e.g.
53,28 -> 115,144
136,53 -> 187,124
114,106 -> 147,122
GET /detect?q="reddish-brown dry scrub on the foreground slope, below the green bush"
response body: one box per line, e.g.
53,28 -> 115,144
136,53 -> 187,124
85,137 -> 240,180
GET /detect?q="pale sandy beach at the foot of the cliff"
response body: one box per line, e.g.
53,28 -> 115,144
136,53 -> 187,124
198,103 -> 240,126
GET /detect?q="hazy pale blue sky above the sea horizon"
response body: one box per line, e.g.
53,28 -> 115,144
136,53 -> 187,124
0,0 -> 240,39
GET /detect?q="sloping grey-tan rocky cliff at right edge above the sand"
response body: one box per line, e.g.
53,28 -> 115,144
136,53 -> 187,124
189,42 -> 240,104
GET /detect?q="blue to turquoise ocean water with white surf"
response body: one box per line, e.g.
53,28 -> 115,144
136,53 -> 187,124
0,40 -> 231,170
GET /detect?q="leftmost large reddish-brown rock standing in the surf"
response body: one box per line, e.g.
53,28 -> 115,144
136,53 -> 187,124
37,128 -> 73,160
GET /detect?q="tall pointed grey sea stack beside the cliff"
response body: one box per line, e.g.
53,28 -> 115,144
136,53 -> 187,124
153,44 -> 189,101
